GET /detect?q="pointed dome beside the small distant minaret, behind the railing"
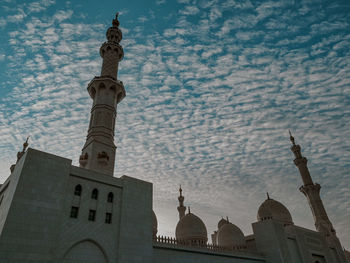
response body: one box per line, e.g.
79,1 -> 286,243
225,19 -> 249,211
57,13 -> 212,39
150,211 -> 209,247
175,213 -> 208,244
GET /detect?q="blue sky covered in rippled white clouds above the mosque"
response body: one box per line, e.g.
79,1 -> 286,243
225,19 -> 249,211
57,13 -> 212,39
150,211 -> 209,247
0,0 -> 350,249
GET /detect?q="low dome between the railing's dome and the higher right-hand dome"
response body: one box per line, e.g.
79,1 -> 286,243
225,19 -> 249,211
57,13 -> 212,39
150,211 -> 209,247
217,223 -> 246,248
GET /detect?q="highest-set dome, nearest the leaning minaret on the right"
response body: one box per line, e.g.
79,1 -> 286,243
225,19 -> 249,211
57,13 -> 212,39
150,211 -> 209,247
257,198 -> 294,225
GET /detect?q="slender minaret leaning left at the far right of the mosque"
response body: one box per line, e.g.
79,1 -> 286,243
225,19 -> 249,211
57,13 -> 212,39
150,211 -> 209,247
289,131 -> 336,237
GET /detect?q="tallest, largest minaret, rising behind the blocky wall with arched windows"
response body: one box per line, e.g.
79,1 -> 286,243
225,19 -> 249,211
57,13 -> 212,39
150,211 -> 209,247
79,13 -> 125,176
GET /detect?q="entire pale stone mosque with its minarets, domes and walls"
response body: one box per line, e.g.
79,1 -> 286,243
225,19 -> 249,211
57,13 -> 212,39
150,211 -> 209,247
0,12 -> 350,263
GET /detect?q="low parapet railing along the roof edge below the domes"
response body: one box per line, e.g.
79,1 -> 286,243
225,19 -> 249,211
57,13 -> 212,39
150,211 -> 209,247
153,236 -> 247,252
